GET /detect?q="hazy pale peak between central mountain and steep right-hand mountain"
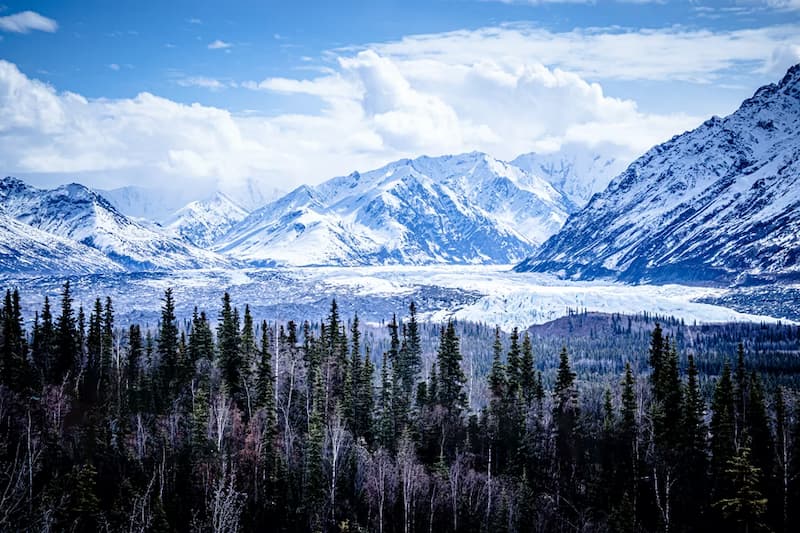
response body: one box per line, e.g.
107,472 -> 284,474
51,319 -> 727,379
511,145 -> 630,207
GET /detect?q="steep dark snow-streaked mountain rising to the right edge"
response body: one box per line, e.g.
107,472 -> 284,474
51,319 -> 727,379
517,65 -> 800,283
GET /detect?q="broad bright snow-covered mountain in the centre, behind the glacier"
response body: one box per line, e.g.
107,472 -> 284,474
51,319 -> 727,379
215,153 -> 574,265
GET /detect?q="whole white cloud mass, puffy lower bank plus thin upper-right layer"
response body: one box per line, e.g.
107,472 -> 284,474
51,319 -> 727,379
6,22 -> 800,197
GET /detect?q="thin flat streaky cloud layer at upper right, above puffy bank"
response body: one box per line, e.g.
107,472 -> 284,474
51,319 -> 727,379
369,24 -> 800,83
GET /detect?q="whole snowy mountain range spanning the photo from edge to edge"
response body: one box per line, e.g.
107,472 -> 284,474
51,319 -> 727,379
0,65 -> 800,285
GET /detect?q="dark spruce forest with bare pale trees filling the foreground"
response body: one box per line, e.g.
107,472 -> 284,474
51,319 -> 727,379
0,283 -> 800,533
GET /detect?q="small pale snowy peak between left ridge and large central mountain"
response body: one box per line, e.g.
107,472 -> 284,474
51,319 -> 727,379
164,192 -> 248,248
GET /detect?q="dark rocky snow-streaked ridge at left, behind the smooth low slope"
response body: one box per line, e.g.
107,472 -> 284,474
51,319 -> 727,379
0,177 -> 229,270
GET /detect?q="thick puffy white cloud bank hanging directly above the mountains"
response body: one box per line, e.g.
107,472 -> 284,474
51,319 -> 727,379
0,50 -> 699,197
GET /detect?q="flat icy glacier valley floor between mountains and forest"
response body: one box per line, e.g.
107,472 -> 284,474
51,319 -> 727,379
0,265 -> 788,331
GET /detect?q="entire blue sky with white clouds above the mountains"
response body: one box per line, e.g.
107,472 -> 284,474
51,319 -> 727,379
0,0 -> 800,200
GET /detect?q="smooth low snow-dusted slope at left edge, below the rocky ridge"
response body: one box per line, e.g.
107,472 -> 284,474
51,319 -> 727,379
0,209 -> 123,274
